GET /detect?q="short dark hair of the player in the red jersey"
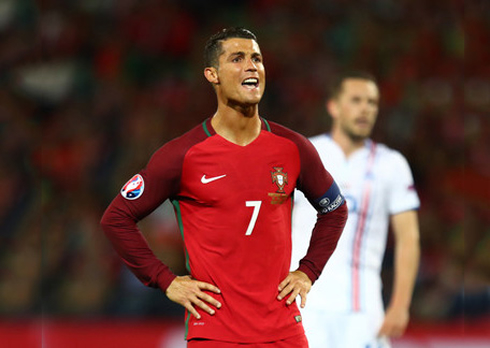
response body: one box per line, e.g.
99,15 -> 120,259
204,27 -> 257,68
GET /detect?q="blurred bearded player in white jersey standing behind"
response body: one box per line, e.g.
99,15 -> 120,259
292,72 -> 420,348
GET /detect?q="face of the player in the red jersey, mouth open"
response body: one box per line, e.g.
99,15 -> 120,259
205,38 -> 265,107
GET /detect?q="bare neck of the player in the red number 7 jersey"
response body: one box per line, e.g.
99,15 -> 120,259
211,108 -> 262,146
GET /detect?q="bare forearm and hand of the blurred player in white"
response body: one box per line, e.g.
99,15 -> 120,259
379,210 -> 420,337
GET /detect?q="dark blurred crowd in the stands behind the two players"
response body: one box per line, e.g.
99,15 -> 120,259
0,0 -> 490,328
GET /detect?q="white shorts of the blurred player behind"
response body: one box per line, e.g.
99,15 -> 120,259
302,305 -> 391,348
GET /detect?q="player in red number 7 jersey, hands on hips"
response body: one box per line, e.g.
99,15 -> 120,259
101,28 -> 347,348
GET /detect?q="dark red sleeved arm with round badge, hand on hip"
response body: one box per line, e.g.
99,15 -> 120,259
101,133 -> 221,317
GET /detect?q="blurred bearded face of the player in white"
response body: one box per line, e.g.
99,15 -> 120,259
328,79 -> 379,141
